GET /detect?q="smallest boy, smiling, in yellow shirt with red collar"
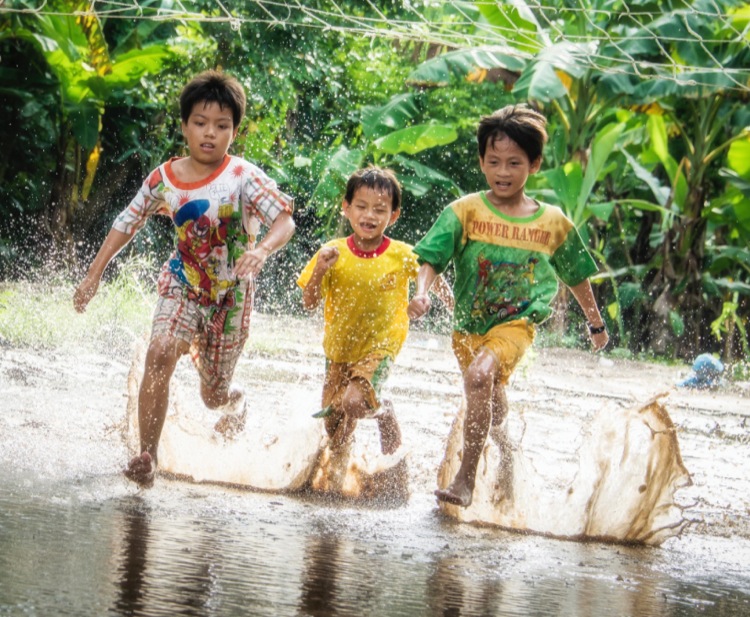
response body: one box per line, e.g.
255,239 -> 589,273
297,167 -> 452,454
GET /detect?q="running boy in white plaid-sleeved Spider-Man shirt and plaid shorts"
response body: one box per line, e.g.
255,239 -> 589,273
73,71 -> 294,486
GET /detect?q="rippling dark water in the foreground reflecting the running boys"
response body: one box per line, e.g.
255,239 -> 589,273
0,482 -> 750,617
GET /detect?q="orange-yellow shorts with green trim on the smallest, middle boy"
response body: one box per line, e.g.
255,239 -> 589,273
315,354 -> 393,418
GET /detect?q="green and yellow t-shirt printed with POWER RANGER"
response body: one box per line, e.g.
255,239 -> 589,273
414,193 -> 597,334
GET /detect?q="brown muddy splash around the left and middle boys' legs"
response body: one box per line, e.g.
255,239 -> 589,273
126,345 -> 409,504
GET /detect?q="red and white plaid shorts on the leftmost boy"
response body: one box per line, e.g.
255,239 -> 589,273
151,281 -> 253,390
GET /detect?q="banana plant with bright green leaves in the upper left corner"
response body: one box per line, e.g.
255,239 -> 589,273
0,0 -> 173,259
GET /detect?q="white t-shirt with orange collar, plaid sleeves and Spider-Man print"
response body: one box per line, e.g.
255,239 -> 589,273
112,156 -> 293,306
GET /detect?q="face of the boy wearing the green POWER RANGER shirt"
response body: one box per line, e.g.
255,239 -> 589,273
479,137 -> 542,205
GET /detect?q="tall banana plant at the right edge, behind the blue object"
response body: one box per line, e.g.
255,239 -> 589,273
601,1 -> 750,358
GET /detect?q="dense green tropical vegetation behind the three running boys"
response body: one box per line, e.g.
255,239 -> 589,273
0,0 -> 750,361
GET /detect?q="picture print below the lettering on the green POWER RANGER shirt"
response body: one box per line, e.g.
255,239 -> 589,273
471,254 -> 539,321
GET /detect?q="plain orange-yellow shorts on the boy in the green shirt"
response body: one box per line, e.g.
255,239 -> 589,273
452,319 -> 536,384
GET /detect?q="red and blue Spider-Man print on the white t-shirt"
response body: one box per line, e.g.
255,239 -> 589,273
170,199 -> 239,304
